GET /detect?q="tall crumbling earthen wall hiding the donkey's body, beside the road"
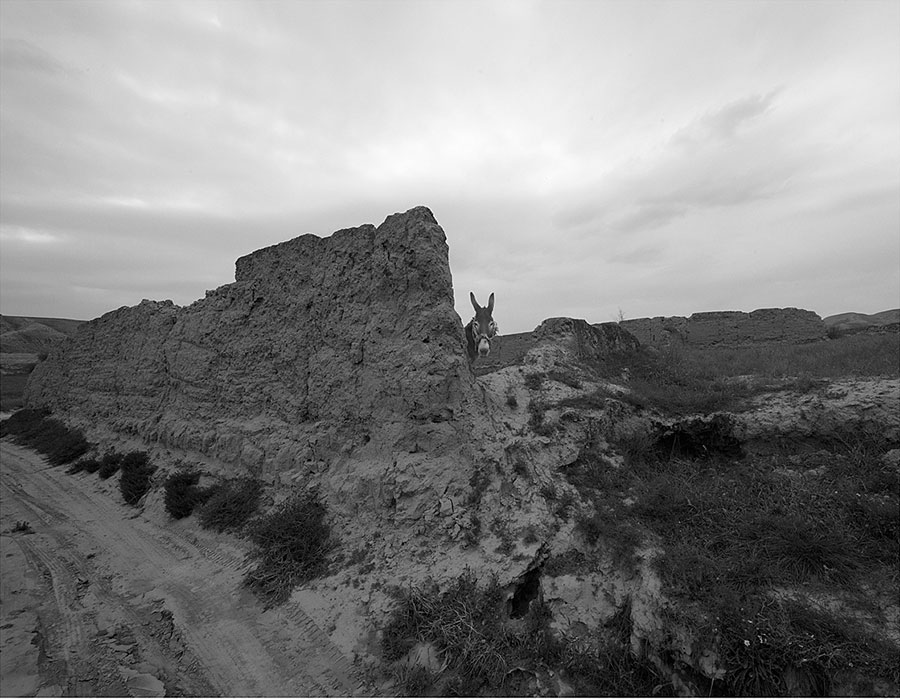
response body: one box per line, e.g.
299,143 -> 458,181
26,207 -> 474,471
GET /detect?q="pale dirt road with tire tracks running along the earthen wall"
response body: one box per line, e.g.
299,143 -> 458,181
0,440 -> 366,697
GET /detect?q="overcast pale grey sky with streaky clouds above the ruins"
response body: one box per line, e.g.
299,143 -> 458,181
0,0 -> 900,332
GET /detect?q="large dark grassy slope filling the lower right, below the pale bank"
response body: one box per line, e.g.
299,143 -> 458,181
557,418 -> 900,695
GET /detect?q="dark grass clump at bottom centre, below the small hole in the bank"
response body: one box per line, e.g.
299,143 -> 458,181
382,572 -> 670,697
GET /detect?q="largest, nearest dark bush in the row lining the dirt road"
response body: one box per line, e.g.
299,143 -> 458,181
244,491 -> 335,606
